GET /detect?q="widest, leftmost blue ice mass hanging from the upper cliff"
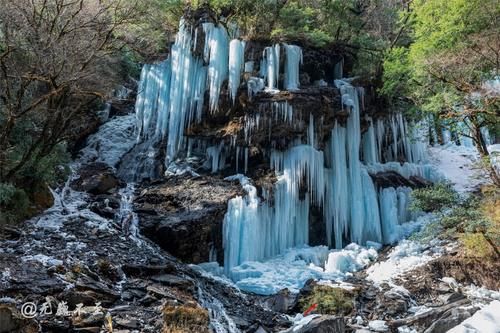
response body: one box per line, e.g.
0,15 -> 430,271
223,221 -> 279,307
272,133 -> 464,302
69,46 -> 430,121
136,20 -> 206,164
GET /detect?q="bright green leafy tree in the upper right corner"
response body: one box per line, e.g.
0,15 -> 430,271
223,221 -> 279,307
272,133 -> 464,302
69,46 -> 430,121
380,0 -> 500,169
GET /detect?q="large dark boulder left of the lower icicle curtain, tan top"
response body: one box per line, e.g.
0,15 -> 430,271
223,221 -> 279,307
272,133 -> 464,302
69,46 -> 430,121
135,176 -> 242,263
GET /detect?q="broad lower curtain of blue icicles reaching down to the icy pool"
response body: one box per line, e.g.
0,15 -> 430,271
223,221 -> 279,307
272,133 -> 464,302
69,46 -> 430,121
224,81 -> 437,279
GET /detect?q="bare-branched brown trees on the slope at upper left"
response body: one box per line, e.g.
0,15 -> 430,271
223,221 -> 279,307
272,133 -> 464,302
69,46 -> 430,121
0,0 -> 142,182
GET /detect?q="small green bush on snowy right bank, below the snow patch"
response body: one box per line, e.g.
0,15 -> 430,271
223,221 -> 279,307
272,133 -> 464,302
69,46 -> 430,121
410,183 -> 458,212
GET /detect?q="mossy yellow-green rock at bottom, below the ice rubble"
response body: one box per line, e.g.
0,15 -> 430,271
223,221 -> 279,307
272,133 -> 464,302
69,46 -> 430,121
299,285 -> 354,315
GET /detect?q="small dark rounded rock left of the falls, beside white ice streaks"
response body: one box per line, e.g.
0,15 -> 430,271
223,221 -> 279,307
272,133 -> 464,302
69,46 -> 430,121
70,163 -> 120,194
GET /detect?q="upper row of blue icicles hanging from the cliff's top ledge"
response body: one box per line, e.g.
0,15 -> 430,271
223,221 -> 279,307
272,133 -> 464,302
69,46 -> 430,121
136,16 -> 302,170
